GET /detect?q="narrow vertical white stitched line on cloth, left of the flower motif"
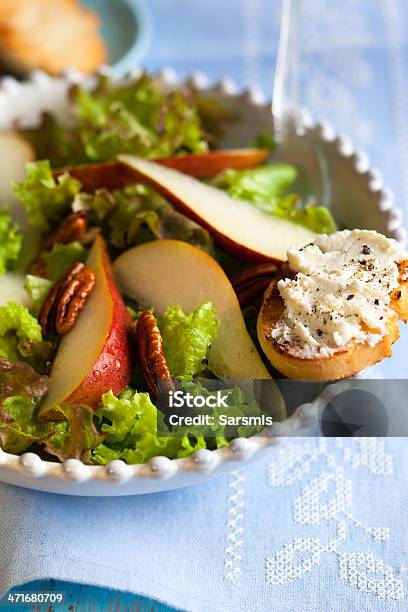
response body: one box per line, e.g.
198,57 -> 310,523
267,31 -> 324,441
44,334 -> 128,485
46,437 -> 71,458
224,472 -> 245,585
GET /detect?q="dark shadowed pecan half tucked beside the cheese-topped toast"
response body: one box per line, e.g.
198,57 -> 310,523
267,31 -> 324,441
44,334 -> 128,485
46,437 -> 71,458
231,262 -> 279,308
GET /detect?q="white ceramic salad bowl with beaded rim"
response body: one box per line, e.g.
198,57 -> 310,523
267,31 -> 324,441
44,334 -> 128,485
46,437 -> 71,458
0,70 -> 406,496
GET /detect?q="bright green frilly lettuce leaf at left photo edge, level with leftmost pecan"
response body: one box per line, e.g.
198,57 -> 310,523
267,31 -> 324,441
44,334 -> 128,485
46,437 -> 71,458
0,302 -> 42,361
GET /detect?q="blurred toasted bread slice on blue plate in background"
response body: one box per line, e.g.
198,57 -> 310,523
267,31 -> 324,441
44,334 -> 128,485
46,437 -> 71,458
0,0 -> 106,74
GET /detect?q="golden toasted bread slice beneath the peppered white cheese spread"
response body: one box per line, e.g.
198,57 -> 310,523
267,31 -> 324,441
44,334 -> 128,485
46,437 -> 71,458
258,261 -> 408,381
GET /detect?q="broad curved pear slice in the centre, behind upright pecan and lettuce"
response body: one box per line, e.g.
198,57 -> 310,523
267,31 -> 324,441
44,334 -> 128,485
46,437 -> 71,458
113,240 -> 286,420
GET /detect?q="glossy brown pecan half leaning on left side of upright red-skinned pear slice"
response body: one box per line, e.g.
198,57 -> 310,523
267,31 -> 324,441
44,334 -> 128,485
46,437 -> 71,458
39,262 -> 95,336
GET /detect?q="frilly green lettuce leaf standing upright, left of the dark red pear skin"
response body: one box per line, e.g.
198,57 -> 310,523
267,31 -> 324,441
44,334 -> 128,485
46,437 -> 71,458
12,160 -> 81,233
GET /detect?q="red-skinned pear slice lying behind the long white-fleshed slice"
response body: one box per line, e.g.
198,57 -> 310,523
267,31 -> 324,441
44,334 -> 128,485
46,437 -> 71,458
53,149 -> 269,193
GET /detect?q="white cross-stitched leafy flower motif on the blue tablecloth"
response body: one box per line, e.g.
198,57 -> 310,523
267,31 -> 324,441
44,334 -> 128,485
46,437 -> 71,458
266,438 -> 405,600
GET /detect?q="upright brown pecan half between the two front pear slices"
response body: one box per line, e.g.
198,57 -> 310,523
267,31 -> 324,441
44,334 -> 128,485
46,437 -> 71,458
134,310 -> 176,397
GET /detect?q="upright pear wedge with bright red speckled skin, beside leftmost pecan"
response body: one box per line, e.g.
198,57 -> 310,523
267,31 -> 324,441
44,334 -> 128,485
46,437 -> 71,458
40,236 -> 131,418
